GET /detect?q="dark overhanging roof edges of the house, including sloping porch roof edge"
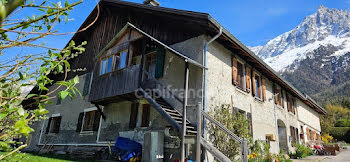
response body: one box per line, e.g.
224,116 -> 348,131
67,0 -> 327,114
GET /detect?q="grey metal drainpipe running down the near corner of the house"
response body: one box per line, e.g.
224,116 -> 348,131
203,26 -> 222,129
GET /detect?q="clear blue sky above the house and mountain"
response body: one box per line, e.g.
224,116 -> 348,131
3,0 -> 350,56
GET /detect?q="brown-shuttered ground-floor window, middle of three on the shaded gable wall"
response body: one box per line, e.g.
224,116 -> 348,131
76,108 -> 101,132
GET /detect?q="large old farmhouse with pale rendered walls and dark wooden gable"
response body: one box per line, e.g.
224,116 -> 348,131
23,0 -> 326,161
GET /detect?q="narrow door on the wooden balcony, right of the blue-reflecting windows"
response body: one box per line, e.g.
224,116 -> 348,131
144,52 -> 157,80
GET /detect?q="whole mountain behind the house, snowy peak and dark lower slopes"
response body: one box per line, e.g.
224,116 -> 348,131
250,6 -> 350,103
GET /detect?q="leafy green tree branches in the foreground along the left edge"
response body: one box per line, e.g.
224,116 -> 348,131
0,0 -> 99,160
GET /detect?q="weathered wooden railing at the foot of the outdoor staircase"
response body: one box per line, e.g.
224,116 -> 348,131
196,103 -> 248,162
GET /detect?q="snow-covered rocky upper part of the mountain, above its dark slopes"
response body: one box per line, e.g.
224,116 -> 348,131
251,6 -> 350,72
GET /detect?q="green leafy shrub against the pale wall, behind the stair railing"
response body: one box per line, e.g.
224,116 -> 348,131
208,105 -> 252,161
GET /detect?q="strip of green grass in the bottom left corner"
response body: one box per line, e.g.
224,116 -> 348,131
0,152 -> 94,162
